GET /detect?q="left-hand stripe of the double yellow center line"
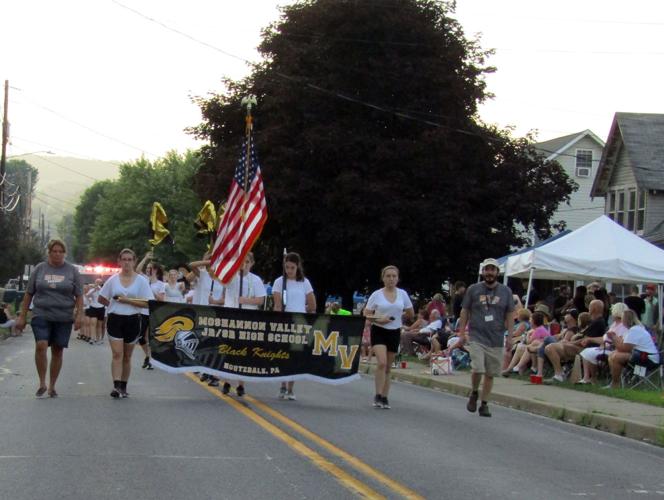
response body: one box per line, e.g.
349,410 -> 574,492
185,373 -> 385,499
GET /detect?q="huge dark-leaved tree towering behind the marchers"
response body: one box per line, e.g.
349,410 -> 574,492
192,0 -> 574,296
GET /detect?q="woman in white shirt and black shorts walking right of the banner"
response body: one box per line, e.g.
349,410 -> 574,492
364,266 -> 414,409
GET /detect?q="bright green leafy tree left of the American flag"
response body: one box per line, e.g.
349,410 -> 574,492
84,152 -> 205,265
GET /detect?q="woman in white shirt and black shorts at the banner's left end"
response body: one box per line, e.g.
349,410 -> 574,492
99,248 -> 154,398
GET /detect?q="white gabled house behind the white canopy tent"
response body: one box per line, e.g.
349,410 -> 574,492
534,130 -> 604,230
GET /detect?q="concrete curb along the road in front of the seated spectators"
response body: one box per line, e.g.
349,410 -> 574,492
360,365 -> 664,446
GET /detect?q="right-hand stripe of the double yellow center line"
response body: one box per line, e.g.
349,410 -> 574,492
245,396 -> 424,500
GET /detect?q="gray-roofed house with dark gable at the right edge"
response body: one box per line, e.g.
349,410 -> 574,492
590,113 -> 664,248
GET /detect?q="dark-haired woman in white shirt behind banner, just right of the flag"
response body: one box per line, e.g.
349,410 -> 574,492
272,252 -> 316,401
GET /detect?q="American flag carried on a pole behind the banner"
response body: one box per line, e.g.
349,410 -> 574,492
210,135 -> 267,285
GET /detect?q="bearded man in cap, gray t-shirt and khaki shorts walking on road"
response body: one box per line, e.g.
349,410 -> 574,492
459,259 -> 514,417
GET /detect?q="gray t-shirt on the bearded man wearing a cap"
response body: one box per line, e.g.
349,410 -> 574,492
462,281 -> 514,347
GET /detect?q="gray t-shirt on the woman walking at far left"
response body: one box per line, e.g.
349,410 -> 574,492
26,262 -> 83,321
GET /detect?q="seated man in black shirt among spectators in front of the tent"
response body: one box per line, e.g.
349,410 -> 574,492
544,300 -> 606,382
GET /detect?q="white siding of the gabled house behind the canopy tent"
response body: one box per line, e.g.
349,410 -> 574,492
552,136 -> 604,230
